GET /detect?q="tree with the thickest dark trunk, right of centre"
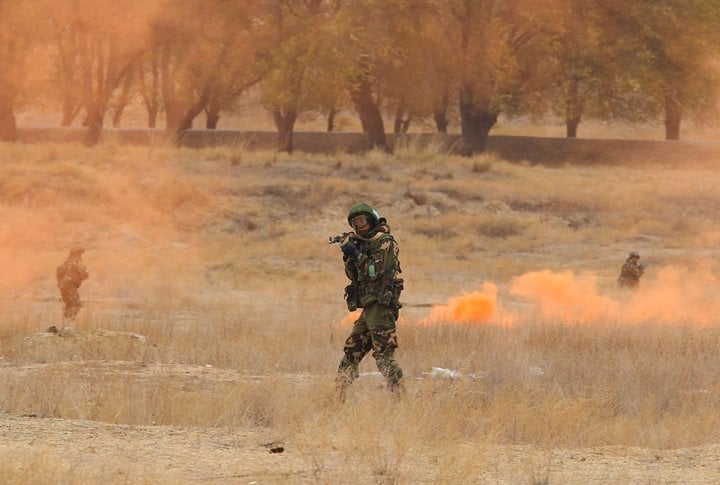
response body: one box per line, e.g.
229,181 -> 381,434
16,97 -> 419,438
441,0 -> 557,155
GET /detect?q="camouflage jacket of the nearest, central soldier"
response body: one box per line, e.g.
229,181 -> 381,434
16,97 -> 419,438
345,226 -> 401,308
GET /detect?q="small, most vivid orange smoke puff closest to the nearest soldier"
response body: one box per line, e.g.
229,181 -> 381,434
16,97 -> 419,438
420,283 -> 510,325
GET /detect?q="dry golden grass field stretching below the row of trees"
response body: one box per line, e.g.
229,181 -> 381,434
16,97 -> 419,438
0,142 -> 720,483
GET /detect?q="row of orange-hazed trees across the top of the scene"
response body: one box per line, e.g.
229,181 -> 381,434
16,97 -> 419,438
0,0 -> 720,154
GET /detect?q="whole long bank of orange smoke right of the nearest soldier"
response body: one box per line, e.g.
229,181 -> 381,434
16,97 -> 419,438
420,263 -> 720,326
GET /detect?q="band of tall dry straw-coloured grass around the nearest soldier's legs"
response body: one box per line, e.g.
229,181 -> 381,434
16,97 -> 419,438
0,292 -> 720,450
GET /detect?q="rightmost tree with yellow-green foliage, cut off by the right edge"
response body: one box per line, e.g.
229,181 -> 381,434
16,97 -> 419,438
603,0 -> 720,140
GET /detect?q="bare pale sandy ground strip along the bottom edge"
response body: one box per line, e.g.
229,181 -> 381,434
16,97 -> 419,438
0,402 -> 720,483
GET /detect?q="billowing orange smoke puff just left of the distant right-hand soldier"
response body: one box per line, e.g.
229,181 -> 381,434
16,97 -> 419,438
510,269 -> 617,322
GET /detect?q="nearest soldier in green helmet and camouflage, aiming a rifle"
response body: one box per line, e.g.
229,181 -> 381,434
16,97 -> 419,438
336,203 -> 403,400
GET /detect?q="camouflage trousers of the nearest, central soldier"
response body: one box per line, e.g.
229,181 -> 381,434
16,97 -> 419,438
336,303 -> 402,398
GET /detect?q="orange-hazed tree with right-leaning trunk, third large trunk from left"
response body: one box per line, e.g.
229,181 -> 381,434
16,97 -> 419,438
153,0 -> 265,141
